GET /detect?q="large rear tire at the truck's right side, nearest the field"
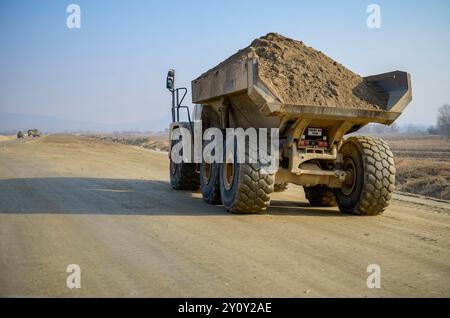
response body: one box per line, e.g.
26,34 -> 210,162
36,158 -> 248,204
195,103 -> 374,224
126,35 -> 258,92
335,136 -> 395,215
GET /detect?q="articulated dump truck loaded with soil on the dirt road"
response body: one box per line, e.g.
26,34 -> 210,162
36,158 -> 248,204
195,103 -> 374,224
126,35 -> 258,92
167,33 -> 412,215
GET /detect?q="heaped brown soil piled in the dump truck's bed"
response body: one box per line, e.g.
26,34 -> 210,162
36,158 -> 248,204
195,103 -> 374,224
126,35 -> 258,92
200,33 -> 387,110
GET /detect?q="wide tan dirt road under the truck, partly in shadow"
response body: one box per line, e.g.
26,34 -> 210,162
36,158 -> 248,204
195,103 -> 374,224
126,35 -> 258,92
0,135 -> 450,297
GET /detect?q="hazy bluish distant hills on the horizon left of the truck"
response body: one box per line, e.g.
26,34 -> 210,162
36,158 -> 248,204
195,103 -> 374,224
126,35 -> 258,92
0,112 -> 170,133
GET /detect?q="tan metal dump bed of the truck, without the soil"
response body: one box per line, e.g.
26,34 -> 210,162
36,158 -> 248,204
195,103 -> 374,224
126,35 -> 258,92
192,58 -> 412,127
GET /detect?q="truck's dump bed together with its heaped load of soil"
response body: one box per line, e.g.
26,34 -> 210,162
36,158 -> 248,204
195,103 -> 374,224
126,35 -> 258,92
192,33 -> 412,125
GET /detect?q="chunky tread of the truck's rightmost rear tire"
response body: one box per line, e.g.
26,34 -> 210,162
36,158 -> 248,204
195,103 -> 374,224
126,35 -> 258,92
345,136 -> 395,215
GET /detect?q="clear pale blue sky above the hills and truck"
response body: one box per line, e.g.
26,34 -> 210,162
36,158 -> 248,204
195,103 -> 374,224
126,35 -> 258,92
0,0 -> 450,125
